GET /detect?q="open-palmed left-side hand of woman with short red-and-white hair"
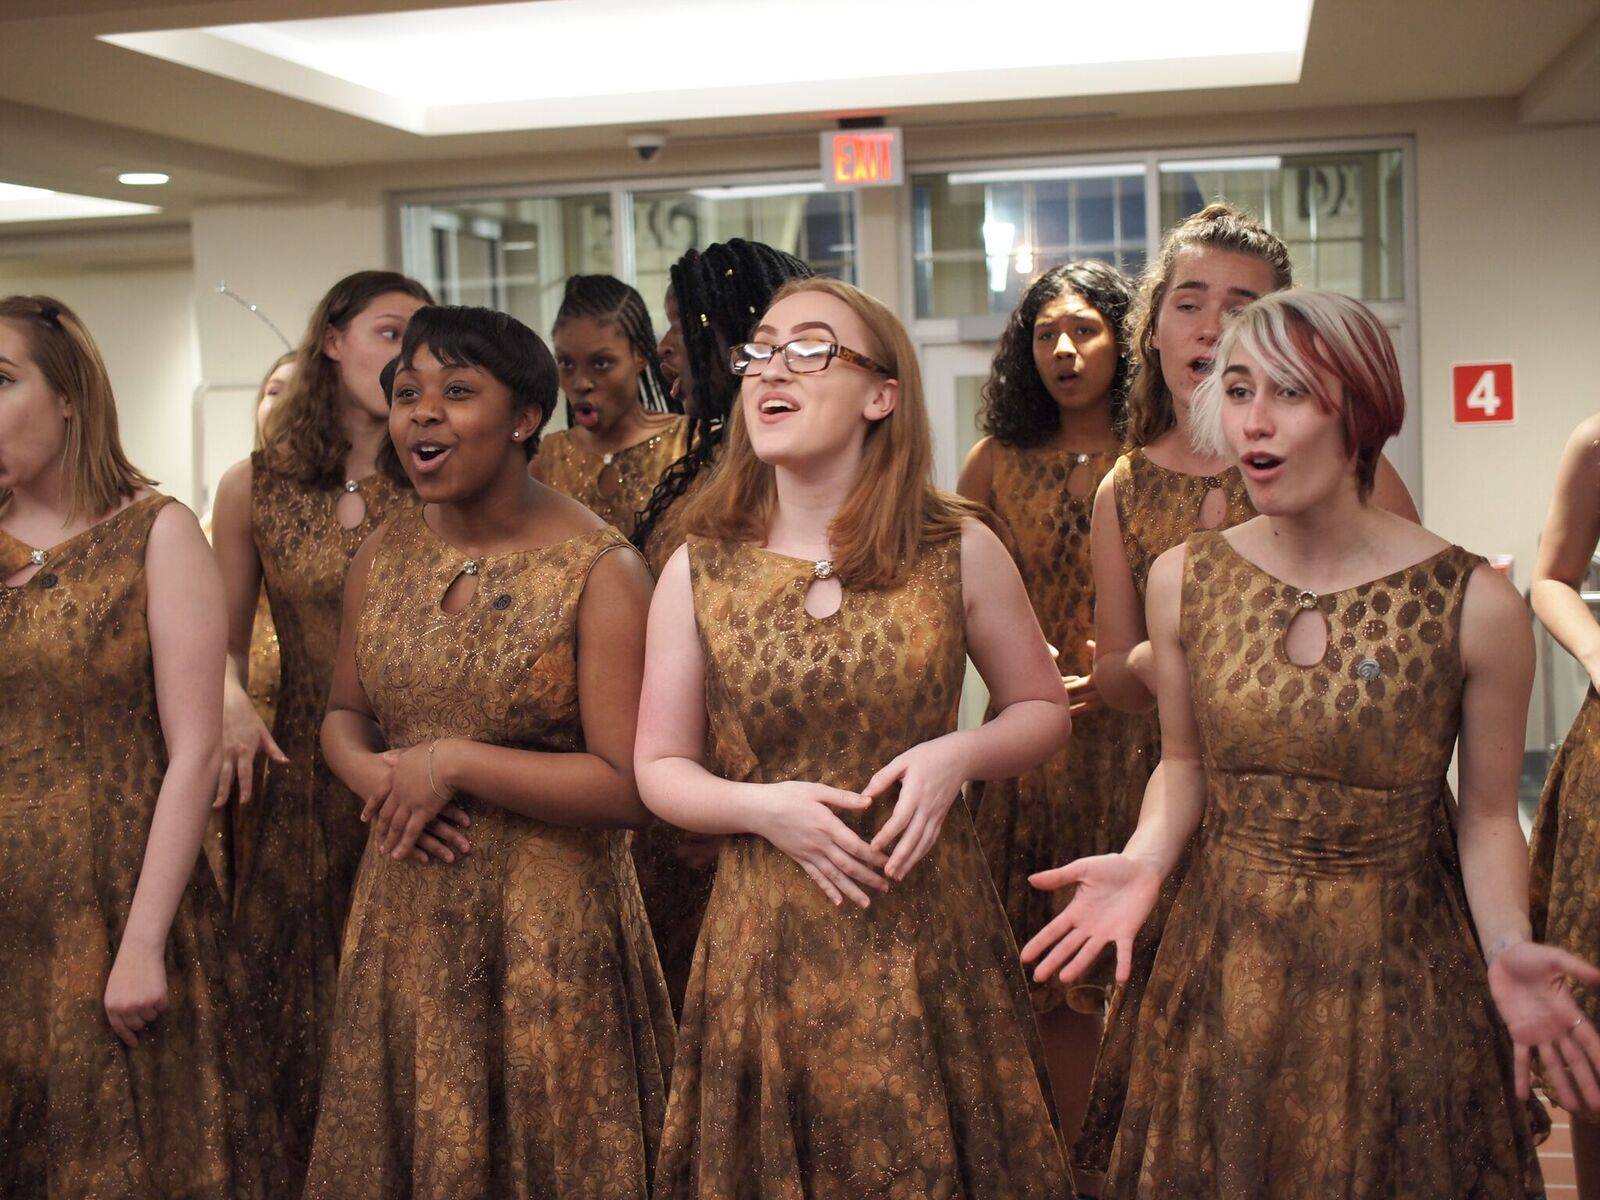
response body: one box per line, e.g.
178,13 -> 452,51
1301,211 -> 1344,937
1022,854 -> 1162,984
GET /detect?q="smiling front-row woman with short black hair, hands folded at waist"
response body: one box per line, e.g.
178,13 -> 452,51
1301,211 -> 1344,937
306,307 -> 672,1200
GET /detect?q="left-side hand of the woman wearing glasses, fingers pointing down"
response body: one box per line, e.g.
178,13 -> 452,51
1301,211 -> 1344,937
754,779 -> 890,909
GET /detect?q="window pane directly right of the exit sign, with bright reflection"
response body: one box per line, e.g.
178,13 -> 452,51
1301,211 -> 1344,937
912,163 -> 1144,317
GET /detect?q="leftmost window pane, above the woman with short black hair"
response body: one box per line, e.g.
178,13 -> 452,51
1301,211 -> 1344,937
400,194 -> 616,338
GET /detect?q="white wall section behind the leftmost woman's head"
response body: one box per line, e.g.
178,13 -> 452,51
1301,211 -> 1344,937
0,264 -> 200,506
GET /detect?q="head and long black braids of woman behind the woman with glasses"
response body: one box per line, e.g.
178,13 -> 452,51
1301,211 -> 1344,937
634,237 -> 816,579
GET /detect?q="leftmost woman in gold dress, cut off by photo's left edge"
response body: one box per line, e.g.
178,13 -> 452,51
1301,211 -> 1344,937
0,296 -> 277,1200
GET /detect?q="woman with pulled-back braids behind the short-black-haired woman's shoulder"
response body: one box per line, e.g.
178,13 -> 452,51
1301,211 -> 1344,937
533,275 -> 690,538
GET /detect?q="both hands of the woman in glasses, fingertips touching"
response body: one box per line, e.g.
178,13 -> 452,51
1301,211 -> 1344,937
752,738 -> 968,909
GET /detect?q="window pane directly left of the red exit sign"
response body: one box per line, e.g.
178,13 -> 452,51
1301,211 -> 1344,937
634,182 -> 856,328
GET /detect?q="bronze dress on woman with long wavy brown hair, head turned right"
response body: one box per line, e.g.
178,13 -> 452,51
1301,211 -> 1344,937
234,453 -> 416,1181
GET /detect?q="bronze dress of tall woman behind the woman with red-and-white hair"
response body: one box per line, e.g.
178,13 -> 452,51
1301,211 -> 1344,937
1072,448 -> 1256,1186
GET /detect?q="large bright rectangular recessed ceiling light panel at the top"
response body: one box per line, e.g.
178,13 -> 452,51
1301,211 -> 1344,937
101,0 -> 1312,134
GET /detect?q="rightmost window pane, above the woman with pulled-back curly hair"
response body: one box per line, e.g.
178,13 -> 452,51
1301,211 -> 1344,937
1162,150 -> 1405,301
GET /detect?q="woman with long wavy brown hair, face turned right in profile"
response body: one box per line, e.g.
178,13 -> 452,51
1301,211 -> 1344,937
211,270 -> 429,1181
